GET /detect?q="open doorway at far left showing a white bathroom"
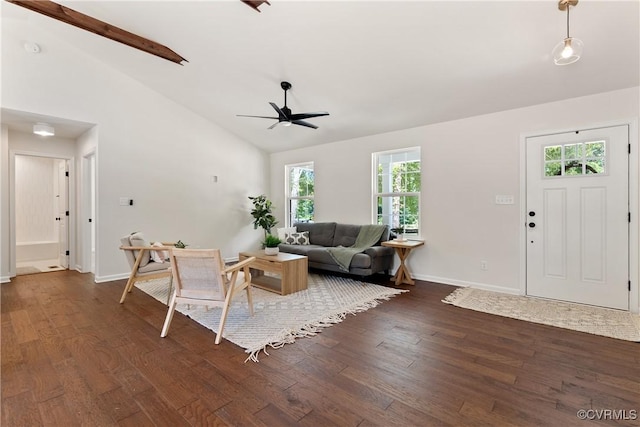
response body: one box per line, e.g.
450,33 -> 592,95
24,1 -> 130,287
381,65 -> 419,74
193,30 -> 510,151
14,154 -> 69,275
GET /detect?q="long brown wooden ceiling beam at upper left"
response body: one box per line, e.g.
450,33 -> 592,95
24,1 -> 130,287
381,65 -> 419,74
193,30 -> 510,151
6,0 -> 188,64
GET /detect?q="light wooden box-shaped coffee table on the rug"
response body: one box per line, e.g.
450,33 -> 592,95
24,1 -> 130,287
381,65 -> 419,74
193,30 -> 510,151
240,251 -> 308,295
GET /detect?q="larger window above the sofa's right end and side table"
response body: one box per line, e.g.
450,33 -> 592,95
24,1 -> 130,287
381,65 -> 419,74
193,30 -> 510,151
373,147 -> 421,237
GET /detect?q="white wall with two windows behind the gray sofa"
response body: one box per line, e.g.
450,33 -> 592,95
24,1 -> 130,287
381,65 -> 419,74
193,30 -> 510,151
271,88 -> 640,304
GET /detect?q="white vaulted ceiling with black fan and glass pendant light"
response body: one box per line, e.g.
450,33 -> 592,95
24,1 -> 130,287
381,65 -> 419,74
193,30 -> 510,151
2,0 -> 640,152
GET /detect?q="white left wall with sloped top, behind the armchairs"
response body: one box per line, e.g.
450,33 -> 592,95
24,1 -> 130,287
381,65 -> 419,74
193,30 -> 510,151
0,14 -> 269,281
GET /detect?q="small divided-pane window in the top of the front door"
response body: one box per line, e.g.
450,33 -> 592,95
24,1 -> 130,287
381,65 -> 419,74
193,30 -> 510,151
544,141 -> 606,177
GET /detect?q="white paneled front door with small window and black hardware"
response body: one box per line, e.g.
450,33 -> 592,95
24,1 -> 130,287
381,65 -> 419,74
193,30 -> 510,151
526,125 -> 629,310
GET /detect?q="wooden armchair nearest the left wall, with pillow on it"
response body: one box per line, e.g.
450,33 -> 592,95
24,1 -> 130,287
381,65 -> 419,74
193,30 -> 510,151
120,233 -> 173,304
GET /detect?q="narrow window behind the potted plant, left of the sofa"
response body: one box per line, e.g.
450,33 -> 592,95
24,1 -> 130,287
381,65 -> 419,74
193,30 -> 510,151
285,162 -> 315,226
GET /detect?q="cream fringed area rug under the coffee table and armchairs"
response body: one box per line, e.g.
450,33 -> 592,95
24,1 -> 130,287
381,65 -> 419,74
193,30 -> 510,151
136,274 -> 408,362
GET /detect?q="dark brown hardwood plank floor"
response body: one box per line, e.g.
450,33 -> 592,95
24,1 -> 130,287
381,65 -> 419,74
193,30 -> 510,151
1,271 -> 640,427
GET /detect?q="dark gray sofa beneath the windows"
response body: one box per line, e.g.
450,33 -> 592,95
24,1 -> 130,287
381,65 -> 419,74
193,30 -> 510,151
279,222 -> 394,276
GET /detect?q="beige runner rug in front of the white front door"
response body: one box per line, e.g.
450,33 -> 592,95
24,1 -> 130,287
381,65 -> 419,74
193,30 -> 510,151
442,288 -> 640,342
